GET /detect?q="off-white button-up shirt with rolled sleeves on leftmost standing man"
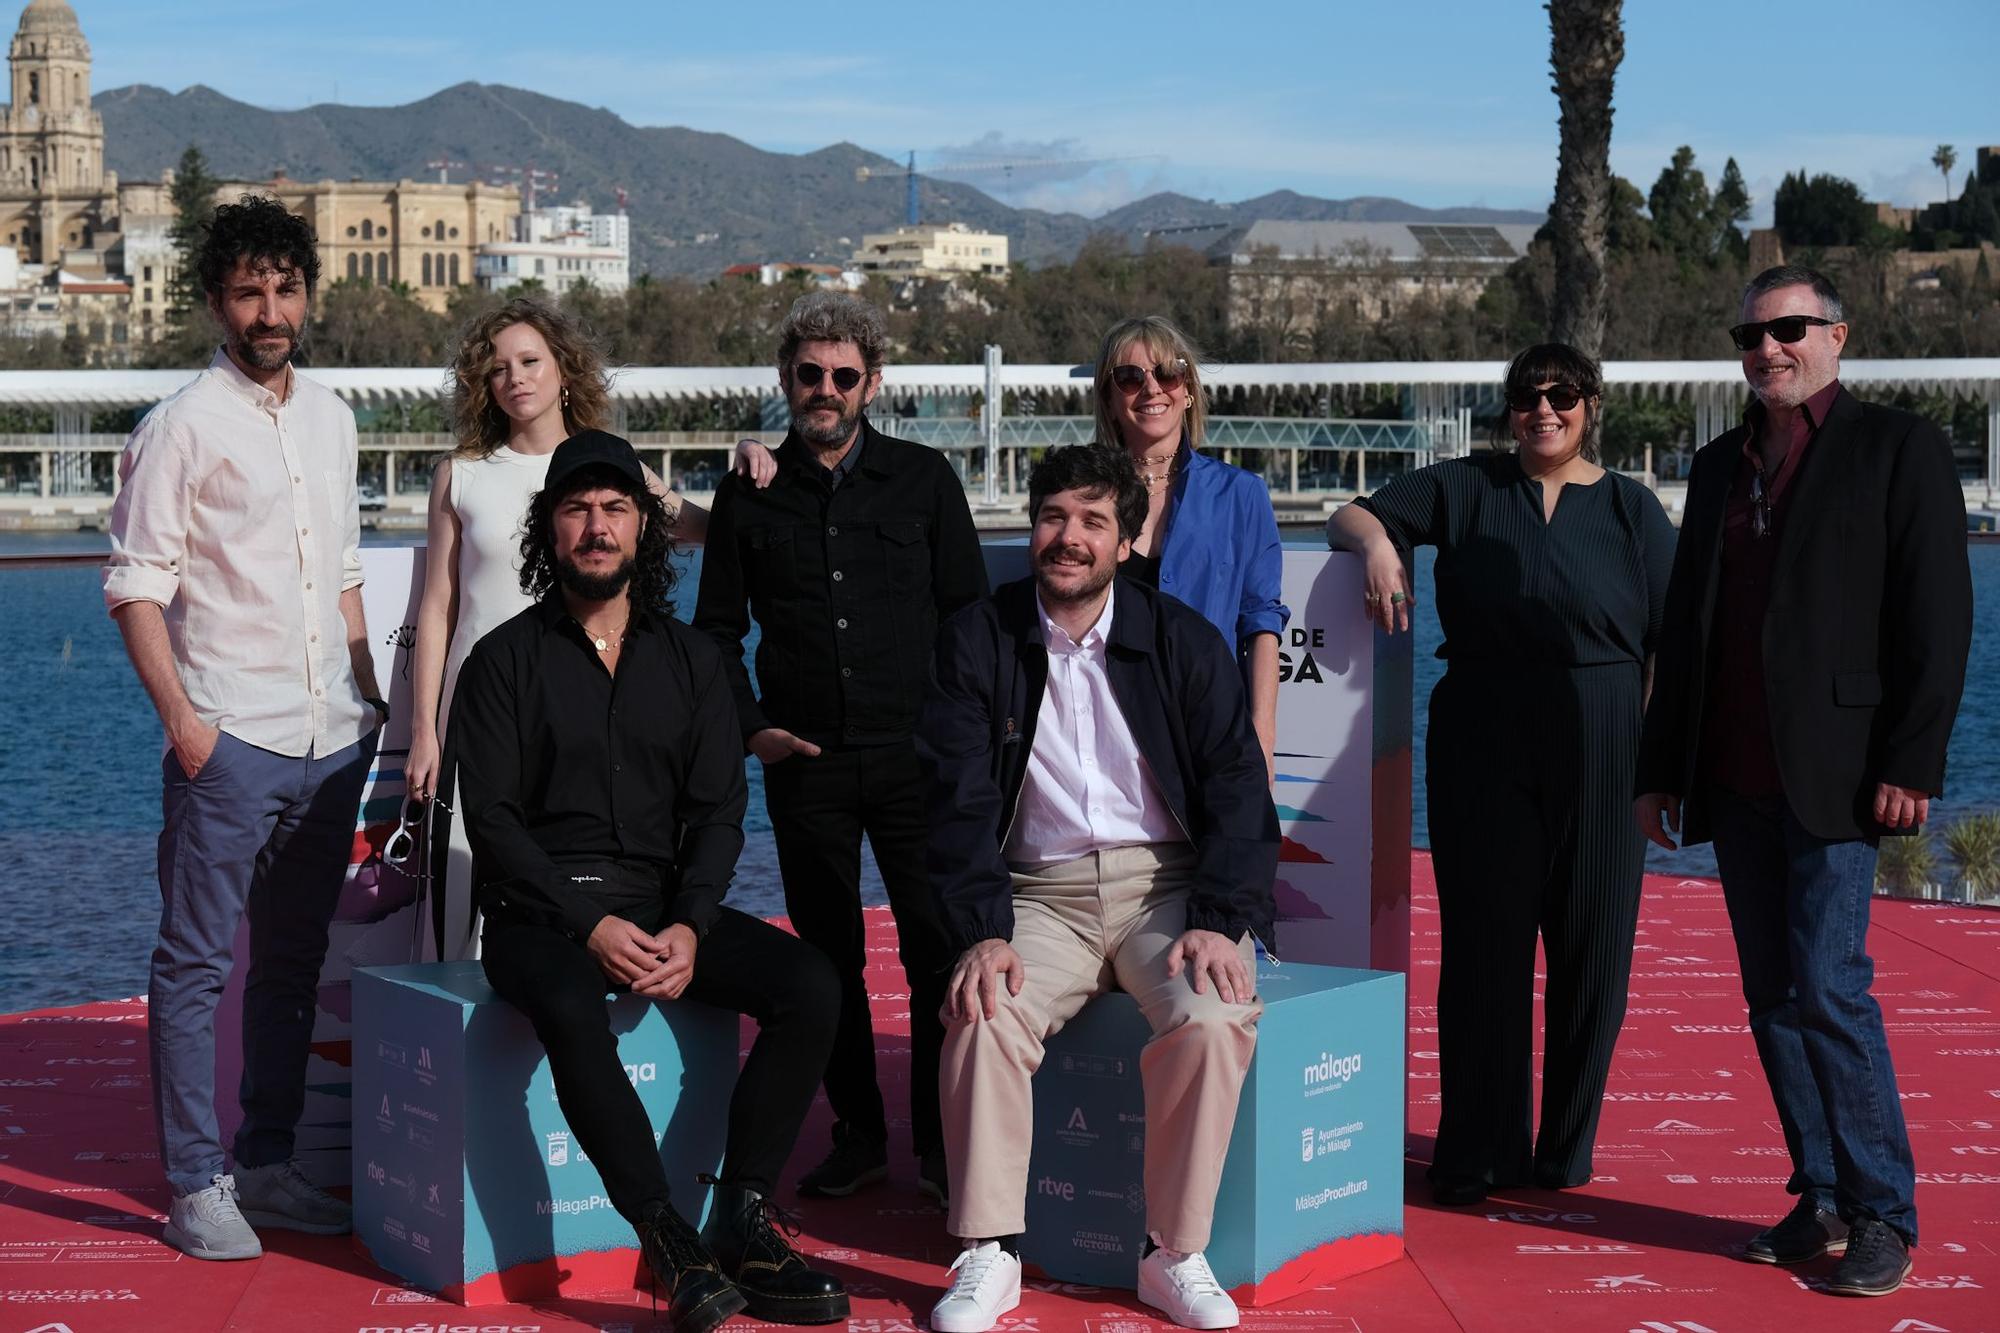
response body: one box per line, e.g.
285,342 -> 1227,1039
104,350 -> 376,757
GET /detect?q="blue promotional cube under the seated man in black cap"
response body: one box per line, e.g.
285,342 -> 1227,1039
354,963 -> 738,1305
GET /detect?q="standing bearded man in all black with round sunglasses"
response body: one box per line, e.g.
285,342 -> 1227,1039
694,292 -> 986,1199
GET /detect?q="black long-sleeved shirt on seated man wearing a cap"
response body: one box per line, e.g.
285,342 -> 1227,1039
450,592 -> 746,939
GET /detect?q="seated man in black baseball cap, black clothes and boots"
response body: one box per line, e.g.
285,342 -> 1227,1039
452,430 -> 848,1333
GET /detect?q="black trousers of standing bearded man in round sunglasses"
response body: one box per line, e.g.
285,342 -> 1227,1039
764,743 -> 956,1153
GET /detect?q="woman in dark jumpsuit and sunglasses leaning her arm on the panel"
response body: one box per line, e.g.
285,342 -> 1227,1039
1328,344 -> 1674,1205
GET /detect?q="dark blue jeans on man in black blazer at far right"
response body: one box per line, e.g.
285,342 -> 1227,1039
1708,791 -> 1916,1245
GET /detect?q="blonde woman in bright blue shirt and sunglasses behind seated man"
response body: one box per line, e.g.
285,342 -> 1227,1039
1096,314 -> 1292,773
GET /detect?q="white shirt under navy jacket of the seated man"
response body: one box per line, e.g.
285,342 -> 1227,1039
1006,590 -> 1188,865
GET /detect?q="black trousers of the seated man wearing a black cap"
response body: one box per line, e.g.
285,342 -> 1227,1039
480,888 -> 840,1227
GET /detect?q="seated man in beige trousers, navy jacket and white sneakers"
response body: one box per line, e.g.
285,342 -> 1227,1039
918,446 -> 1278,1333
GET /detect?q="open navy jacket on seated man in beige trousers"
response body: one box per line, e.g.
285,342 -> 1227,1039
916,578 -> 1278,949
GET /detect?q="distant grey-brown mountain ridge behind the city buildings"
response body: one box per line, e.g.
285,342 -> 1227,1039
94,84 -> 1542,276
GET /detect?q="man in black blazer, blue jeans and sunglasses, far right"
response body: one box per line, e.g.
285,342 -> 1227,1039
1634,266 -> 1972,1295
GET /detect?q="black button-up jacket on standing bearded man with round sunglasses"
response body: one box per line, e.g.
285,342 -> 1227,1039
694,418 -> 986,747
